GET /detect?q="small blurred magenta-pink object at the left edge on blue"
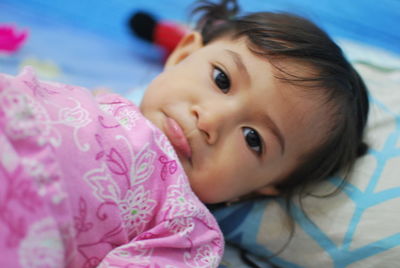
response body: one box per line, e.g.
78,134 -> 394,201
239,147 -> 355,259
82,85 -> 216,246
0,25 -> 28,54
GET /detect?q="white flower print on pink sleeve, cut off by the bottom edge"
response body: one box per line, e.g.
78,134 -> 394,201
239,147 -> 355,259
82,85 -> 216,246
184,245 -> 220,268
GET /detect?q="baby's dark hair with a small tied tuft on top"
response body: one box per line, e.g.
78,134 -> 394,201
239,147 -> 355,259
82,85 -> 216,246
193,0 -> 369,202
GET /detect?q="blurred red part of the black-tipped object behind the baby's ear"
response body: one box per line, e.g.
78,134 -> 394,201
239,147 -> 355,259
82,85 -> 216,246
153,22 -> 187,56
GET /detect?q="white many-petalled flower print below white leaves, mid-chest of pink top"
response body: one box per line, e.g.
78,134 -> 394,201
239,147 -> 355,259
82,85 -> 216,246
118,186 -> 157,235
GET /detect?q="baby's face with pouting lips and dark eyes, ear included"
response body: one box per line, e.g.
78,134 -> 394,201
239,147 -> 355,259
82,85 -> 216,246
141,33 -> 326,203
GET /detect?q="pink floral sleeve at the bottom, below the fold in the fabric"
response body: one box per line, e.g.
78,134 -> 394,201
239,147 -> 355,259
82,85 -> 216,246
99,217 -> 223,268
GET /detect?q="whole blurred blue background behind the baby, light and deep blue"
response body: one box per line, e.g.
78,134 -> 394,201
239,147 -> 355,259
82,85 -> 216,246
0,0 -> 400,98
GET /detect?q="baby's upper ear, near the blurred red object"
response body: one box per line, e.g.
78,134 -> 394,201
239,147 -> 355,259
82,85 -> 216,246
165,32 -> 203,68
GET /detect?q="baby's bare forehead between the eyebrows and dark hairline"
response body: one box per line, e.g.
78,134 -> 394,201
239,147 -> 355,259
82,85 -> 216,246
264,62 -> 335,152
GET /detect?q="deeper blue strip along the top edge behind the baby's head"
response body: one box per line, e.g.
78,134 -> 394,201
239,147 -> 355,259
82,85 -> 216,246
0,0 -> 400,53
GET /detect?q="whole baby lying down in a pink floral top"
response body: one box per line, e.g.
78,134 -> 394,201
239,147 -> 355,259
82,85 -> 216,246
0,1 -> 368,267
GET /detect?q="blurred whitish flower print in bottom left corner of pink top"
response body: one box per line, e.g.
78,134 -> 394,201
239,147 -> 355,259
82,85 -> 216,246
18,218 -> 65,268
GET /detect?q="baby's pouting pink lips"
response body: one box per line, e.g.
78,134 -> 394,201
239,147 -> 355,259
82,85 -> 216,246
165,117 -> 192,160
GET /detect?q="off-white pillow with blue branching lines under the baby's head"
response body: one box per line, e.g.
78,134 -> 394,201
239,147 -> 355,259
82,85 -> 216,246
214,43 -> 400,268
